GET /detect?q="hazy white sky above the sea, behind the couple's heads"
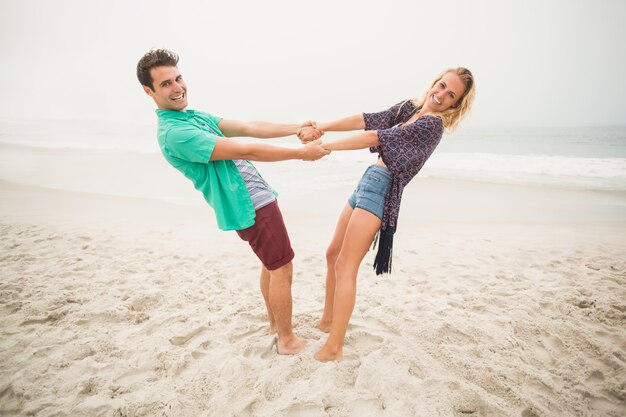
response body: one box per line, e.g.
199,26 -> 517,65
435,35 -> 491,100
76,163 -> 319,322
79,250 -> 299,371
0,0 -> 626,126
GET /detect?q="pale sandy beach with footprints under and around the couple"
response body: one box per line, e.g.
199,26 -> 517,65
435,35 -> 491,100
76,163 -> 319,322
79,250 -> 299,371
0,139 -> 626,417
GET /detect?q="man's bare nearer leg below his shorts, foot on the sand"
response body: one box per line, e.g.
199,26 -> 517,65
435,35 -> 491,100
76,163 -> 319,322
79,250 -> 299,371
269,262 -> 306,355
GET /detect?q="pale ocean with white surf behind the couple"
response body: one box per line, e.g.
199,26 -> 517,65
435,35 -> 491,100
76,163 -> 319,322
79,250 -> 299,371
0,120 -> 626,204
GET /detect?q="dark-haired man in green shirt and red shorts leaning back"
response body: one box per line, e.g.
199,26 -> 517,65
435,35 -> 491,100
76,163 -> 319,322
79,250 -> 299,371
137,49 -> 329,354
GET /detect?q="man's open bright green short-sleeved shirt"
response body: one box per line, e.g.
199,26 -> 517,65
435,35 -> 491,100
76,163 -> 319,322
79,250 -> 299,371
156,110 -> 256,230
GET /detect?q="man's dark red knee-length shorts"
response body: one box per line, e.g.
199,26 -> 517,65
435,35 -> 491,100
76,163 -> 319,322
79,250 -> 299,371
237,200 -> 295,271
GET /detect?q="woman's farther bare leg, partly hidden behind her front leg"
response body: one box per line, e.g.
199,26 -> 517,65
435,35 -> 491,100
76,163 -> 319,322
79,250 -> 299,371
315,204 -> 353,333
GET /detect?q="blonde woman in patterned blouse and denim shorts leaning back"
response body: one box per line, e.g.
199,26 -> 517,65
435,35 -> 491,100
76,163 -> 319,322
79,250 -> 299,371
298,67 -> 474,362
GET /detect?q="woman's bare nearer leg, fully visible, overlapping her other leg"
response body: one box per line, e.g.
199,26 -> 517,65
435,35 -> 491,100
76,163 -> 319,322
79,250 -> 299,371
315,208 -> 381,362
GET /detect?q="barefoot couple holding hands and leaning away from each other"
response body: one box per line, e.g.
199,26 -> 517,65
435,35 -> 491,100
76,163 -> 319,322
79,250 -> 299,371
137,49 -> 475,362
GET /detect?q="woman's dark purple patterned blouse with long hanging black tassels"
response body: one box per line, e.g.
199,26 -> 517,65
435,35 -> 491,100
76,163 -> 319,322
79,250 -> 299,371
363,101 -> 443,273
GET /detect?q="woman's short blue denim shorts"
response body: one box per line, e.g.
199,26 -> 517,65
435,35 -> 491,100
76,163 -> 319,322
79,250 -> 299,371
348,165 -> 391,220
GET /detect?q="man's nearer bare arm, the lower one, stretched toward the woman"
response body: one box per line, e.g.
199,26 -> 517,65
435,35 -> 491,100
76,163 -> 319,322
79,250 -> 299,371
211,138 -> 330,162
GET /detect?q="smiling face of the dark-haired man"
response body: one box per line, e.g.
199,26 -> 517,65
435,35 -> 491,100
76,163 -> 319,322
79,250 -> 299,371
143,67 -> 187,111
